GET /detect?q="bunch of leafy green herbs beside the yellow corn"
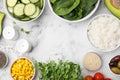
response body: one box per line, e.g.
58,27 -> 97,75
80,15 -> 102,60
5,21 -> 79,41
35,60 -> 84,80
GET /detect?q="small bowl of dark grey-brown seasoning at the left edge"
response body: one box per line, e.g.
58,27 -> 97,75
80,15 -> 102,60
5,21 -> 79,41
0,51 -> 8,69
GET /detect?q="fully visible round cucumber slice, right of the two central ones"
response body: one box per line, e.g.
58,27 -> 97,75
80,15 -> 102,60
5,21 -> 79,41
24,3 -> 36,16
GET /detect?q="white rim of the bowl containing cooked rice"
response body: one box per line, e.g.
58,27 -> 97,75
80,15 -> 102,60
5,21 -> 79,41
86,13 -> 120,52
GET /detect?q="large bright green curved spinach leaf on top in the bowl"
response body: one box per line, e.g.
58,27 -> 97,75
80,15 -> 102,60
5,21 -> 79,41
53,0 -> 80,16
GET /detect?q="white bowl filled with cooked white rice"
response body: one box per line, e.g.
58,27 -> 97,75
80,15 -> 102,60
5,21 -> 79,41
87,14 -> 120,52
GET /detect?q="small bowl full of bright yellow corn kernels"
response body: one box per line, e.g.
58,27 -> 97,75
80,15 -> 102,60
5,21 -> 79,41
10,58 -> 35,80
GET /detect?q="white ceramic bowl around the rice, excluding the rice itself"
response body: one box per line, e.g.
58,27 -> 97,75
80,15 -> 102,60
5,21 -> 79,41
87,14 -> 120,52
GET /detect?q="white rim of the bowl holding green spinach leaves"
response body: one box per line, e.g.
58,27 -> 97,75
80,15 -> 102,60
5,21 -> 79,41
48,0 -> 101,23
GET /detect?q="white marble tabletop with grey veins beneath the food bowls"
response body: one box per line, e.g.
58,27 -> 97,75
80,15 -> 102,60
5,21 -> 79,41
0,0 -> 120,80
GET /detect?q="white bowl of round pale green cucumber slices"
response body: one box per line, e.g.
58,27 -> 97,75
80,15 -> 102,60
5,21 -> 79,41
5,0 -> 45,22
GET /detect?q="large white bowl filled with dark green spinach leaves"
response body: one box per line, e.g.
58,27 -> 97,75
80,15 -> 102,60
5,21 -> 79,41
48,0 -> 100,22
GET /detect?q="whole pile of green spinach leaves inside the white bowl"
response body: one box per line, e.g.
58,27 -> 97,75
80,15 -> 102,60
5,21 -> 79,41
51,0 -> 98,20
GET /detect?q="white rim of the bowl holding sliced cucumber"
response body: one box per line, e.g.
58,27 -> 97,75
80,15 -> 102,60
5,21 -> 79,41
4,0 -> 45,23
